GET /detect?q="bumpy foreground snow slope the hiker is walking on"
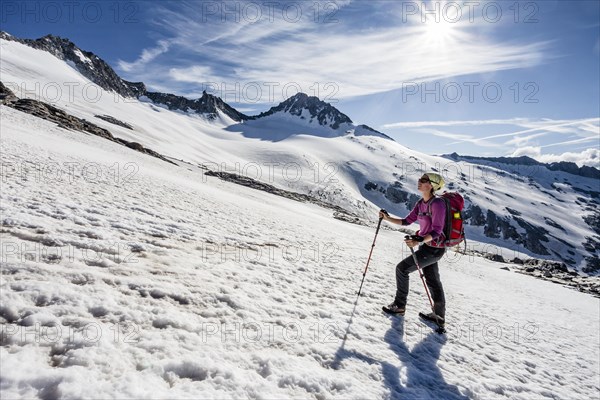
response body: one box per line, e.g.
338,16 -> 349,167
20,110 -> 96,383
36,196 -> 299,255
0,106 -> 600,399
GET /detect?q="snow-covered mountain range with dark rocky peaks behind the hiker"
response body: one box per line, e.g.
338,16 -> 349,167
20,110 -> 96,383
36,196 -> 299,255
0,32 -> 600,274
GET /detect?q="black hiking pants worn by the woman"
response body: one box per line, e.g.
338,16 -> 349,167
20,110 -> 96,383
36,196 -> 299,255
394,244 -> 446,318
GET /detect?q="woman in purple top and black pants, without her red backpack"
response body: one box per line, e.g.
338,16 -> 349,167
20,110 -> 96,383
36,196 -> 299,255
379,172 -> 446,327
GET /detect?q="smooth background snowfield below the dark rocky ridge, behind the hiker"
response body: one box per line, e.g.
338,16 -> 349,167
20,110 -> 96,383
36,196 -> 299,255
0,40 -> 598,271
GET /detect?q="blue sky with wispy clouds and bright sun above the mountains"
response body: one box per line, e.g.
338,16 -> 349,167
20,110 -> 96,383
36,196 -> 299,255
0,0 -> 600,166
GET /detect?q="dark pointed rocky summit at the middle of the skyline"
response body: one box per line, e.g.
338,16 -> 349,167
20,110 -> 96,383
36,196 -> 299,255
253,93 -> 354,132
